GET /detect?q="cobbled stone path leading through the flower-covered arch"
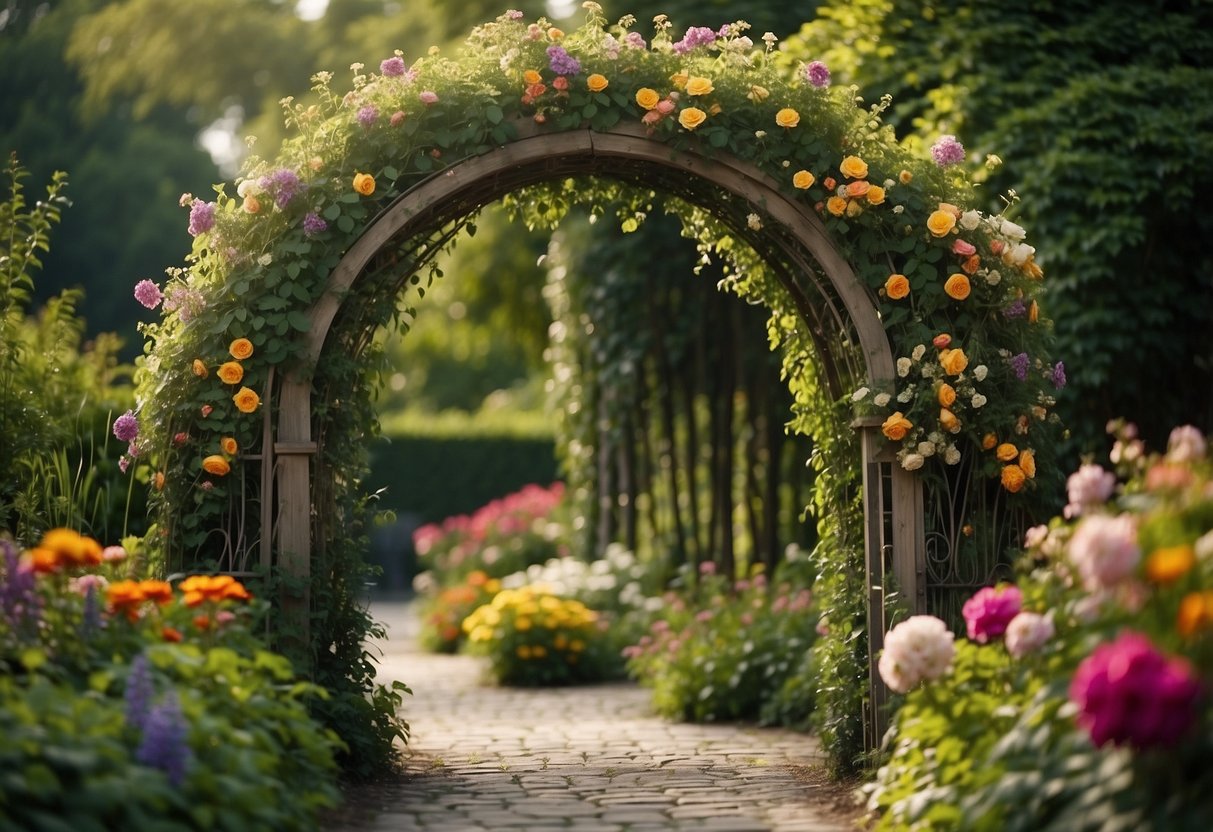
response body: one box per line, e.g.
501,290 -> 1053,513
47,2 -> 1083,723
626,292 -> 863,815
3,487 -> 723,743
328,603 -> 853,832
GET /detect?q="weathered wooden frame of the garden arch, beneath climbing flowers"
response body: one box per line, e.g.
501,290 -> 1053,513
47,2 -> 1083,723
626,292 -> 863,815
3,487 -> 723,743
272,122 -> 924,739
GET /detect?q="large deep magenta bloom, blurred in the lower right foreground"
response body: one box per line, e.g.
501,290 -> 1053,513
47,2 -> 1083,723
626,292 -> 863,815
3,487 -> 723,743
1070,631 -> 1201,748
